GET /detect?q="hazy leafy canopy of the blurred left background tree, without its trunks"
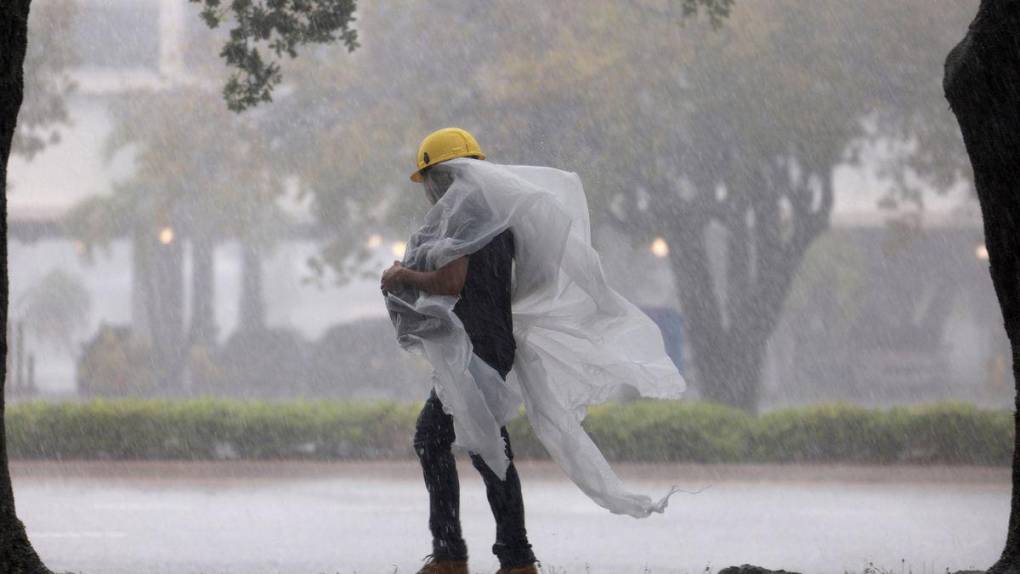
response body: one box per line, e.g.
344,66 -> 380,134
68,87 -> 286,247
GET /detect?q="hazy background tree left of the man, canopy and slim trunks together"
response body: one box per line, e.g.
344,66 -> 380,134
67,88 -> 285,388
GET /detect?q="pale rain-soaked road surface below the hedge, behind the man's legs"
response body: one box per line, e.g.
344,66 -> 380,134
12,462 -> 1010,574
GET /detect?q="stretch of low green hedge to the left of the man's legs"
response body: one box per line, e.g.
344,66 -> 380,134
7,400 -> 417,459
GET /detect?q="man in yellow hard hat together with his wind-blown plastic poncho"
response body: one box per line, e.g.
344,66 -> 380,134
381,127 -> 684,574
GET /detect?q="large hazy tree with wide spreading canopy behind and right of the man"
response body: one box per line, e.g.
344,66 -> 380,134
277,0 -> 968,410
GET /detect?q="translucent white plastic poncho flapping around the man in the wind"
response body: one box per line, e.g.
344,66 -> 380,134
387,159 -> 684,518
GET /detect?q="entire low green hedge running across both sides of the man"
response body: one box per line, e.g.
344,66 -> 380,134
7,400 -> 1014,465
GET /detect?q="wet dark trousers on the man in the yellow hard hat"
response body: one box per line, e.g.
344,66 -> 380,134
414,390 -> 536,568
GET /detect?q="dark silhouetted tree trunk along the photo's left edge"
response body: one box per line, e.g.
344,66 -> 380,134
0,0 -> 50,574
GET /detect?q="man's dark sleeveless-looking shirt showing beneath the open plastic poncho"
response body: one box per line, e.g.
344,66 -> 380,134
453,229 -> 516,378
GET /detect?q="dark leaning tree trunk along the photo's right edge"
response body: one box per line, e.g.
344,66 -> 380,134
944,0 -> 1020,574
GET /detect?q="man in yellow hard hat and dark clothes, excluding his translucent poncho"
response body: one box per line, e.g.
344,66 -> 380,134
383,128 -> 538,574
